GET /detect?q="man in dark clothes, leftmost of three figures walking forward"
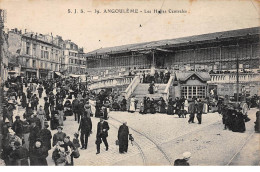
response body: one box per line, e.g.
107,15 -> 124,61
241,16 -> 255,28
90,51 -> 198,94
78,115 -> 92,149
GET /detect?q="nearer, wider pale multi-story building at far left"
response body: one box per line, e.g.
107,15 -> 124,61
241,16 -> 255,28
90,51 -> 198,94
8,29 -> 62,78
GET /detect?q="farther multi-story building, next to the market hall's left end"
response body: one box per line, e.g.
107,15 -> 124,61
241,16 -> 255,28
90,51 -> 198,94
62,40 -> 86,74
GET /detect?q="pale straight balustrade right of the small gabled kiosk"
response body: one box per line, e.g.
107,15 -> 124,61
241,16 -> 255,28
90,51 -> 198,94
208,73 -> 260,84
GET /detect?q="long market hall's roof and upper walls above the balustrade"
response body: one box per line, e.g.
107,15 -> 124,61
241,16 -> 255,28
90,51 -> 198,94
86,27 -> 260,71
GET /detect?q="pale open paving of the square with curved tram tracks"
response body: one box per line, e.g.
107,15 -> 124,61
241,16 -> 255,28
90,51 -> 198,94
9,86 -> 260,166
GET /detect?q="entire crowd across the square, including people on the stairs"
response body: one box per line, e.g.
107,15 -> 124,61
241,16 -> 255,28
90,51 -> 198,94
1,75 -> 260,165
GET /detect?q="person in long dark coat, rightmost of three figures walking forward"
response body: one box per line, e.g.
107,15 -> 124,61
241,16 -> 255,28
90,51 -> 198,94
117,122 -> 129,153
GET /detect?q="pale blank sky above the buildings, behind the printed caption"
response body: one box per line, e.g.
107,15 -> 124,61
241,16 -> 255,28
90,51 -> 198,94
0,0 -> 260,52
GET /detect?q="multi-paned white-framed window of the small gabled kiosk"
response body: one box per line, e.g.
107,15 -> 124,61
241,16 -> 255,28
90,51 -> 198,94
182,86 -> 207,99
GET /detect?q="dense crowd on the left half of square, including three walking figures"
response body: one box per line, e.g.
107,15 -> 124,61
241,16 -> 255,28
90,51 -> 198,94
1,78 -> 134,165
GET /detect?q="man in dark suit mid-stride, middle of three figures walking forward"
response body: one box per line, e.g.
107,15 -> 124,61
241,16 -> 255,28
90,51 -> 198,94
96,118 -> 109,154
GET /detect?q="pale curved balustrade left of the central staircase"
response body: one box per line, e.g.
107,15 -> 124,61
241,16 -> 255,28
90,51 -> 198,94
89,76 -> 133,90
